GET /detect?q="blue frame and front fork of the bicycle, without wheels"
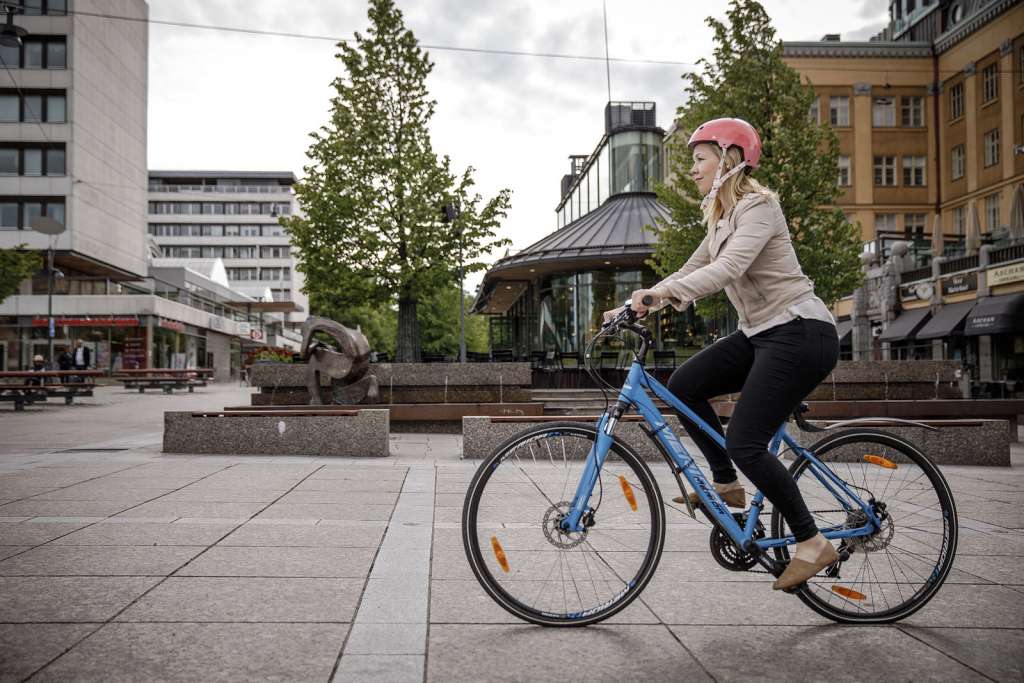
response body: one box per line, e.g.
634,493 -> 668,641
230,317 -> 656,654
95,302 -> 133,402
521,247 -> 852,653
562,360 -> 882,551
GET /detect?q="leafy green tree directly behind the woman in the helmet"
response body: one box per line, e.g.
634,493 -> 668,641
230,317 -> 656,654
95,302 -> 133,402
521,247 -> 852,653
649,0 -> 862,316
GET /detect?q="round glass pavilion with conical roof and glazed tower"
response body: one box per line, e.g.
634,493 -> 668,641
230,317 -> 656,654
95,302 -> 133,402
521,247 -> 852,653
472,102 -> 720,358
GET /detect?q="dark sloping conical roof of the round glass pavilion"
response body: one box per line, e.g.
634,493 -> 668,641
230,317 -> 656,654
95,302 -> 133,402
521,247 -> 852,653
487,193 -> 672,278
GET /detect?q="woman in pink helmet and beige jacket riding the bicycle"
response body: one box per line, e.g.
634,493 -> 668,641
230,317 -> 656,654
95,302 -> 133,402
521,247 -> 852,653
605,119 -> 839,590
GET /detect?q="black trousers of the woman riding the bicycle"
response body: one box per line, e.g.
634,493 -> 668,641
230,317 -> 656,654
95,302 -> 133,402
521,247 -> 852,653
669,317 -> 839,541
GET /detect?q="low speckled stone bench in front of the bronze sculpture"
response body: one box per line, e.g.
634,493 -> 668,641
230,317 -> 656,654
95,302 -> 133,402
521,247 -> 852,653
164,407 -> 390,458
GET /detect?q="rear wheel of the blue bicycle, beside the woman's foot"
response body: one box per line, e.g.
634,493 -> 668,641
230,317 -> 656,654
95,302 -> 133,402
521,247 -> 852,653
771,429 -> 957,624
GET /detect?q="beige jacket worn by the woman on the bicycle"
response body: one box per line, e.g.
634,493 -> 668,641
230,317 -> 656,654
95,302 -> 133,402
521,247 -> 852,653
653,193 -> 823,329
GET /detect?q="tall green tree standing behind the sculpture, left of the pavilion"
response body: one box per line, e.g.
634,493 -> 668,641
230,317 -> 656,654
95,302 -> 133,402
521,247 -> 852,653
282,0 -> 509,361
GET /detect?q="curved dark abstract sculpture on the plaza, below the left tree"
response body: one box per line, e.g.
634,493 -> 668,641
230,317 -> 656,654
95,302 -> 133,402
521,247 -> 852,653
301,316 -> 380,405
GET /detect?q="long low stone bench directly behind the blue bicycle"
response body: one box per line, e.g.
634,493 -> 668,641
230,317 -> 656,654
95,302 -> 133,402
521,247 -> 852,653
462,413 -> 1010,467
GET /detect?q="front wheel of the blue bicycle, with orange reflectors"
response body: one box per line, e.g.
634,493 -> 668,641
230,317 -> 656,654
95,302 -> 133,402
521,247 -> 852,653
462,423 -> 665,626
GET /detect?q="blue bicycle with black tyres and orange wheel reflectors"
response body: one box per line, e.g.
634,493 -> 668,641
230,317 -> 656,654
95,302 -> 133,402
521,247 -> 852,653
462,306 -> 957,626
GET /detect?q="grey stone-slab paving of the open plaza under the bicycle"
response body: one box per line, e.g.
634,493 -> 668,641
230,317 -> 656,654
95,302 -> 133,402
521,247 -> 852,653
0,386 -> 1024,681
